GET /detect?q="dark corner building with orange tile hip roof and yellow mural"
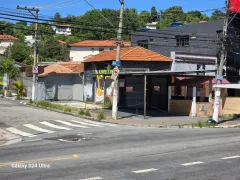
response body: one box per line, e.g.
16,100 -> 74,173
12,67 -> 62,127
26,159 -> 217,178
83,46 -> 172,110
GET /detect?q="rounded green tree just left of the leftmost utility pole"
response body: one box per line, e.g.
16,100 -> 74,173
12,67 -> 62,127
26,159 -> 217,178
11,42 -> 31,62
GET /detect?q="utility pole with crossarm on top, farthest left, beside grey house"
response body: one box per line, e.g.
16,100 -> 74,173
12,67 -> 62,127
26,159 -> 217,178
17,6 -> 39,101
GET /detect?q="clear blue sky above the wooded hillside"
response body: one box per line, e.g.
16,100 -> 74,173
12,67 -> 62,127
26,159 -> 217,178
0,0 -> 225,17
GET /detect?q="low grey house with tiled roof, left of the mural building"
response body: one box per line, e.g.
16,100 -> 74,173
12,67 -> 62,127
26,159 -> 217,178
36,62 -> 84,101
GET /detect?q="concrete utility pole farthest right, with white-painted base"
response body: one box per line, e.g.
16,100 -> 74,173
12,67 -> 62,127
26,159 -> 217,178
213,0 -> 229,123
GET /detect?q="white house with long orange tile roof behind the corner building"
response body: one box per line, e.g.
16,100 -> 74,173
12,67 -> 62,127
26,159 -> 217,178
70,40 -> 131,62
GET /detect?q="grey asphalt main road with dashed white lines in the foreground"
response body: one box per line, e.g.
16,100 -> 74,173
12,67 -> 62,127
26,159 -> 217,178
0,99 -> 240,180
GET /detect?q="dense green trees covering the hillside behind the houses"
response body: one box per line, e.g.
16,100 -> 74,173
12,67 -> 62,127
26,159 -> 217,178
0,6 -> 225,65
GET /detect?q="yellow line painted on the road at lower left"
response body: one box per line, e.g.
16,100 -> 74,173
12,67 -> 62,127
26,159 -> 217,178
0,154 -> 80,167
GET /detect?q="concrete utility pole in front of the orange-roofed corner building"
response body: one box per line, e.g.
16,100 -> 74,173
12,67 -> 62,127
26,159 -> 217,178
112,0 -> 124,120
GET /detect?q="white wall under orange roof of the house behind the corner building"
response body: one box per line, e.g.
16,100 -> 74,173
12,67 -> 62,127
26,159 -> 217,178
69,47 -> 113,62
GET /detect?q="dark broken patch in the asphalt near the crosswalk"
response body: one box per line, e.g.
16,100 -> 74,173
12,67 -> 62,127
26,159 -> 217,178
47,135 -> 94,142
